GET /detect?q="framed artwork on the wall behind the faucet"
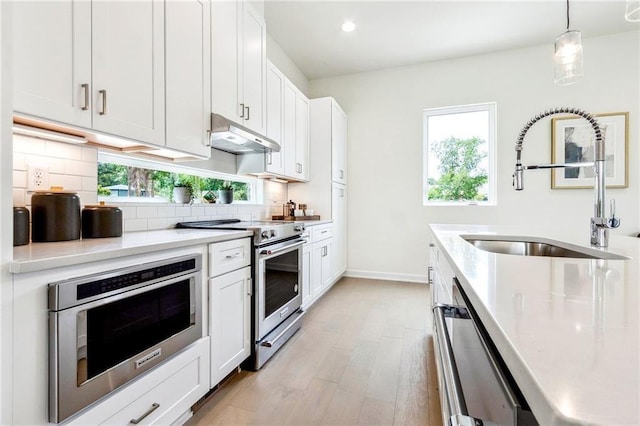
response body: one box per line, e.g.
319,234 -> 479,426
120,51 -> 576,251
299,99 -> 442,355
551,112 -> 629,189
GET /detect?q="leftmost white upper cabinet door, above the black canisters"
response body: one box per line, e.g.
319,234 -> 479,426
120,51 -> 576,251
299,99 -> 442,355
13,0 -> 91,127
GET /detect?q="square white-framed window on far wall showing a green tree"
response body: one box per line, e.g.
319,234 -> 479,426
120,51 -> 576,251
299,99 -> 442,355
423,102 -> 496,205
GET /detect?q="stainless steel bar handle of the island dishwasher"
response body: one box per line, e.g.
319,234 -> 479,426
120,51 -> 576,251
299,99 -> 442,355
433,303 -> 497,426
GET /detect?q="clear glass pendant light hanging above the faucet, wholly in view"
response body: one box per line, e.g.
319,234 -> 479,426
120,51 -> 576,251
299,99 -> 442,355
553,0 -> 584,86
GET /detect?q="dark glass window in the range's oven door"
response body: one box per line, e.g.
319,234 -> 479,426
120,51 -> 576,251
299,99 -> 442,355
264,250 -> 298,318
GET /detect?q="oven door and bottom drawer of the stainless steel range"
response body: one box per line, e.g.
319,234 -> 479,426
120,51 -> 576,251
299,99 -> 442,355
254,236 -> 305,369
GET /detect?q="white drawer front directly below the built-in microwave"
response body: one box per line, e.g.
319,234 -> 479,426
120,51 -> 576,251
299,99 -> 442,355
66,337 -> 210,425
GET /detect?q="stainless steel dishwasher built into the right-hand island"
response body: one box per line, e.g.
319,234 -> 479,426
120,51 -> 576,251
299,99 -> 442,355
433,278 -> 538,426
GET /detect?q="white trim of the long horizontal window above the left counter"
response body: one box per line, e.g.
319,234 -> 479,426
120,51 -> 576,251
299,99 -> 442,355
98,151 -> 264,205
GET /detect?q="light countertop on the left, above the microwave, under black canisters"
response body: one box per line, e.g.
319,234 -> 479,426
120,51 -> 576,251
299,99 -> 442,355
9,229 -> 253,274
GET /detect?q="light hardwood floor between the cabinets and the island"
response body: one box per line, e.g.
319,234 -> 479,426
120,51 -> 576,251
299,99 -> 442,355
187,278 -> 442,426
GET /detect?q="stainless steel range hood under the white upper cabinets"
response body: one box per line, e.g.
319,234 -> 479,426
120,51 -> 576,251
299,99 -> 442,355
211,114 -> 280,154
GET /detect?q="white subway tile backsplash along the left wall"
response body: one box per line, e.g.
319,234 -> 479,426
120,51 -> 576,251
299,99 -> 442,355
13,135 -> 287,232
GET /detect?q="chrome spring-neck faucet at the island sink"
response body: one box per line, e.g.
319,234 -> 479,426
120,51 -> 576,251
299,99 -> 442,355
513,108 -> 620,247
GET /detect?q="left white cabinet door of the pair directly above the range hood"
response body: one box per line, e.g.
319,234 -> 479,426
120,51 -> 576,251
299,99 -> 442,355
211,0 -> 244,123
